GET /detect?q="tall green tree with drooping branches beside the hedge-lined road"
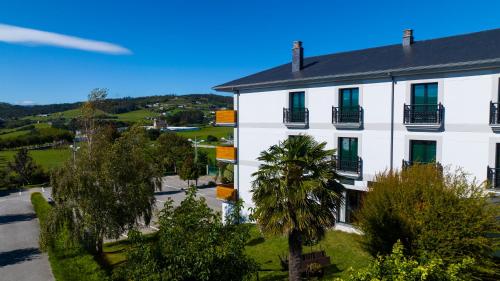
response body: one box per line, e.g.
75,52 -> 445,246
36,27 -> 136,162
46,92 -> 160,253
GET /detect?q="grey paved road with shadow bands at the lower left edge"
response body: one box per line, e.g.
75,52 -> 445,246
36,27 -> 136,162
0,189 -> 54,281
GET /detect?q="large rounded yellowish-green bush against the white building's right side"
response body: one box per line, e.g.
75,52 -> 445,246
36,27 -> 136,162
357,165 -> 500,276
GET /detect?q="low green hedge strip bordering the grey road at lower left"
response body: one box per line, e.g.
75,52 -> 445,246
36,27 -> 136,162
31,192 -> 108,281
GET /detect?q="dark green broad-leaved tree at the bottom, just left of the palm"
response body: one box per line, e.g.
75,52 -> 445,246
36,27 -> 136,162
115,188 -> 257,281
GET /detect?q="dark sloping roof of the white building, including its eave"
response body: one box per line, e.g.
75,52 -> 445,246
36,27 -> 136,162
214,28 -> 500,91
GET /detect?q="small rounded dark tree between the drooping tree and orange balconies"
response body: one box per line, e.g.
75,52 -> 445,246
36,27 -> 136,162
157,132 -> 193,171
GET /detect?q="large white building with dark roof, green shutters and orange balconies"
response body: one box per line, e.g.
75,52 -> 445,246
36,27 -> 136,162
214,29 -> 500,230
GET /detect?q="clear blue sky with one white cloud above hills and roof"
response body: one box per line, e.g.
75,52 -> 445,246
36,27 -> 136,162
0,0 -> 500,105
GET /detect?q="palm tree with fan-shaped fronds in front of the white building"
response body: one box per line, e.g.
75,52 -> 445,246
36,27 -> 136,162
252,135 -> 341,281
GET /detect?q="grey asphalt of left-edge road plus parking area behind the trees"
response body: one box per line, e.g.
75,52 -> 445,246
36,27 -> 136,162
0,176 -> 222,281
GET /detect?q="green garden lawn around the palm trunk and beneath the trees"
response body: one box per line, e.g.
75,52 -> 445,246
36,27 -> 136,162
103,226 -> 372,280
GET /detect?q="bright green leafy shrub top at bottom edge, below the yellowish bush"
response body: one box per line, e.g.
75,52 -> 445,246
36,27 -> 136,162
340,242 -> 474,281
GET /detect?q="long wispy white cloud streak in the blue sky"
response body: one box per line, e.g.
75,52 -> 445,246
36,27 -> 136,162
0,24 -> 132,55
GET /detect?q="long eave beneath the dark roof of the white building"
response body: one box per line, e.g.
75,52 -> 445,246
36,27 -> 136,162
212,58 -> 500,92
